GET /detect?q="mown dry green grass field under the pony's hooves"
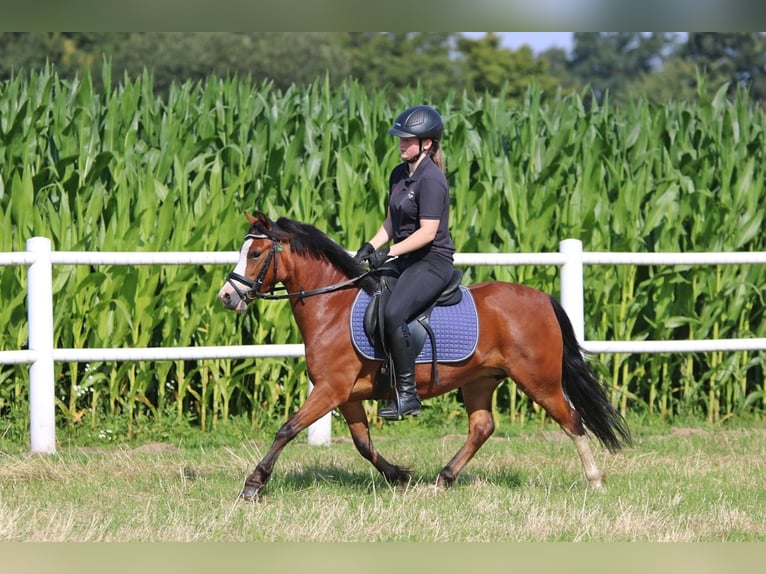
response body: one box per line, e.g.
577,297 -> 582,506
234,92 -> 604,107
0,423 -> 766,542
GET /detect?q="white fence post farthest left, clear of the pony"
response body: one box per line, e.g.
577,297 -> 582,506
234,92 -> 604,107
27,237 -> 56,454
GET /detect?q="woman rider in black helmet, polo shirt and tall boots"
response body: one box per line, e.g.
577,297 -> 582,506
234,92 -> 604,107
355,106 -> 455,420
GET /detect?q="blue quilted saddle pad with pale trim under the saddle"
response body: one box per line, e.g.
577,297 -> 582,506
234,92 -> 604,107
351,285 -> 479,363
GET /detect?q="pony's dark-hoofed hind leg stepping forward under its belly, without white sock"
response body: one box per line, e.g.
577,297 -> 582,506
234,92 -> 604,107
436,378 -> 498,487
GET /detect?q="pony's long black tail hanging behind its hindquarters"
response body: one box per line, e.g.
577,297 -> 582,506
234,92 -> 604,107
550,297 -> 632,452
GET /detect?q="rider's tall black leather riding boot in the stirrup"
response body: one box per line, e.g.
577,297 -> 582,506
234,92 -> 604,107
378,325 -> 425,421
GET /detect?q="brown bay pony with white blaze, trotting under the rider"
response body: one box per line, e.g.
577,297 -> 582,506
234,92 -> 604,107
218,213 -> 631,500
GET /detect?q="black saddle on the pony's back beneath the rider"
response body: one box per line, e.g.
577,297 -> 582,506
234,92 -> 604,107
363,267 -> 463,396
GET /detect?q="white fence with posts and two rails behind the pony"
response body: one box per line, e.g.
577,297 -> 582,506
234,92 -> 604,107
0,237 -> 766,453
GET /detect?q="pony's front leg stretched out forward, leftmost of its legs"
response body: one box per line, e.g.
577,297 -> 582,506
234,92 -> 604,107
239,386 -> 338,500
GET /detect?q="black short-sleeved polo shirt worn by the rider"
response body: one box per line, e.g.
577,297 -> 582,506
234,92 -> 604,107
388,156 -> 455,261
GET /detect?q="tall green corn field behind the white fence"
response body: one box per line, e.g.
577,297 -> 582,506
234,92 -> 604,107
0,65 -> 766,436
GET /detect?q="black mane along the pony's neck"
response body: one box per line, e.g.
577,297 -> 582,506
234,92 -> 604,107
258,217 -> 377,294
